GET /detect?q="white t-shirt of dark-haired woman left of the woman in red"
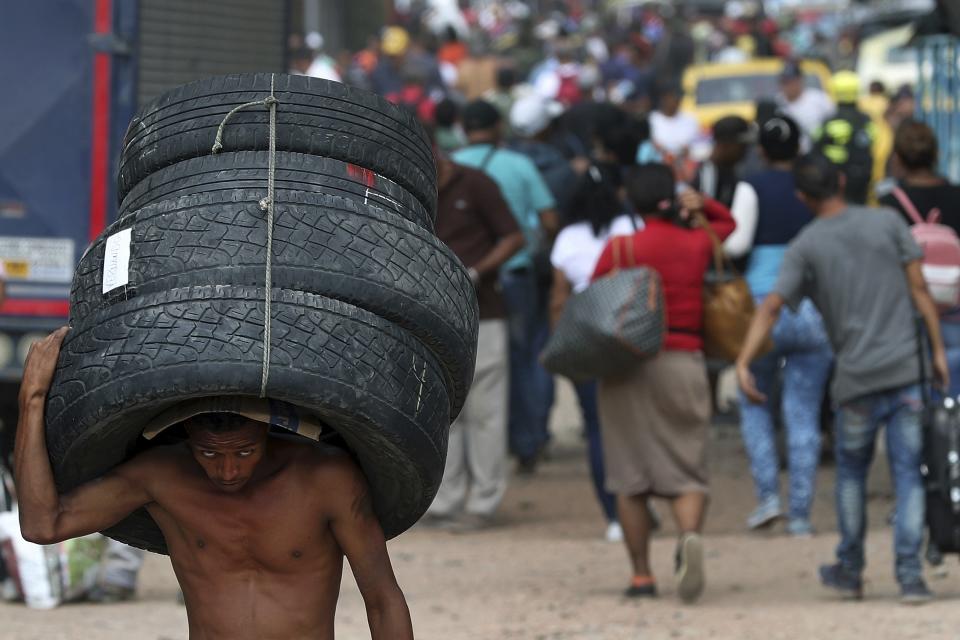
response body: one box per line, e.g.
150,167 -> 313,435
550,214 -> 643,293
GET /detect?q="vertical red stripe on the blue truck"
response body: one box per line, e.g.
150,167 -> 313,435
90,0 -> 113,240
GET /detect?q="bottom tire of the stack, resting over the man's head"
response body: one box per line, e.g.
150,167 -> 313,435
46,285 -> 449,553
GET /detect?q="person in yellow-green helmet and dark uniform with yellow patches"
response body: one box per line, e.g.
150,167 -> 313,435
813,71 -> 877,204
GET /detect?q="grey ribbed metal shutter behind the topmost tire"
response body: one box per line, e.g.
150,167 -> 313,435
137,0 -> 287,104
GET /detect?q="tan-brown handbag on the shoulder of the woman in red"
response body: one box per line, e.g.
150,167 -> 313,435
695,213 -> 773,362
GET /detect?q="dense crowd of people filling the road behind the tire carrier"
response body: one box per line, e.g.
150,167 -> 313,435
286,3 -> 960,602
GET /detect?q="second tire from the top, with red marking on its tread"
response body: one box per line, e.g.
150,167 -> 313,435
120,151 -> 434,232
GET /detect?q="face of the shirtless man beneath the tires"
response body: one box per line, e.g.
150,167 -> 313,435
187,420 -> 267,493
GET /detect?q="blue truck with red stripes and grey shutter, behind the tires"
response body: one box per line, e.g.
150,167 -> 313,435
0,0 -> 292,461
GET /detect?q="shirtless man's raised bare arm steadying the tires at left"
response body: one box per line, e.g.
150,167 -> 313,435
14,327 -> 150,544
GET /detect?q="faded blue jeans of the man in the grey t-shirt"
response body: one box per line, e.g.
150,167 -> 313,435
836,385 -> 925,584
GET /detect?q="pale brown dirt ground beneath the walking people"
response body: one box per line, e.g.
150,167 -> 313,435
0,388 -> 960,640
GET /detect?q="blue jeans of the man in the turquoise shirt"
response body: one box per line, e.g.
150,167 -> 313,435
500,271 -> 554,459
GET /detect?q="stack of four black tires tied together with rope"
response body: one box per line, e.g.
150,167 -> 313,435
46,74 -> 477,553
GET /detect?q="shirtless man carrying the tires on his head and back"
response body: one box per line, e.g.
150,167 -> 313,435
14,328 -> 413,640
